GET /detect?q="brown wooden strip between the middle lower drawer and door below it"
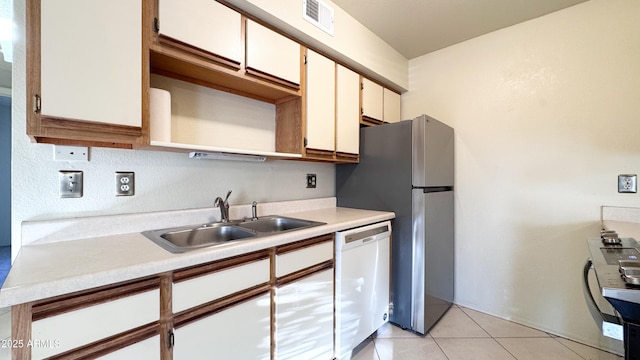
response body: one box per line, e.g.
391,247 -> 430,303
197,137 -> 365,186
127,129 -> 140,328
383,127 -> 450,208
173,283 -> 271,329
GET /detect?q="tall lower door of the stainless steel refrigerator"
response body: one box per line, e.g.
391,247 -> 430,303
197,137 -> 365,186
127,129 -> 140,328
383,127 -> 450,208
411,189 -> 454,334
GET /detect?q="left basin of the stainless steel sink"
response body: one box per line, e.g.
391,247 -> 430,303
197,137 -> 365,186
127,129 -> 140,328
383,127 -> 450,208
142,223 -> 257,253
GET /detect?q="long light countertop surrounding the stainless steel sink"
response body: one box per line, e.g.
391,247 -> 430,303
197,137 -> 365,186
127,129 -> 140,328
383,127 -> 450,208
0,200 -> 395,307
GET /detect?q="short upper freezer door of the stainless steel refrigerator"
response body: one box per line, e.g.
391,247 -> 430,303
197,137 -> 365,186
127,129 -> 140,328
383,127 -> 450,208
411,115 -> 453,187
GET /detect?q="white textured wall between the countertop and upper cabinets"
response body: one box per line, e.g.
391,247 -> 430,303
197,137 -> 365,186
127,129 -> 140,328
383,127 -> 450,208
11,0 -> 335,258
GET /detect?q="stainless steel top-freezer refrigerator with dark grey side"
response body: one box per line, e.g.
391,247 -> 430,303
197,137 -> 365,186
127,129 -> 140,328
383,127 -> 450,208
336,115 -> 454,334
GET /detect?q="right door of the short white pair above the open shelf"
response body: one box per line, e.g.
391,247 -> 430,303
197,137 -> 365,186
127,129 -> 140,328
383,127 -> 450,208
246,20 -> 300,86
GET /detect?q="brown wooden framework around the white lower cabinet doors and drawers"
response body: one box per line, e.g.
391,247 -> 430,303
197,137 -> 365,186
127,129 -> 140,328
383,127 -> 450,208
12,233 -> 335,360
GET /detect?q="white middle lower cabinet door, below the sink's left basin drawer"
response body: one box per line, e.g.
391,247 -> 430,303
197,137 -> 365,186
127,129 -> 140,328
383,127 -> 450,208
173,294 -> 271,360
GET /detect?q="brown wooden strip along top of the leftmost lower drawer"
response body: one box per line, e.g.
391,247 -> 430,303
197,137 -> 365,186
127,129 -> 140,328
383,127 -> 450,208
32,277 -> 160,321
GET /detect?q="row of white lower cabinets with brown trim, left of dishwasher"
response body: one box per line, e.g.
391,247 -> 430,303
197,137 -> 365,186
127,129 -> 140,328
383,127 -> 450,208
11,233 -> 334,360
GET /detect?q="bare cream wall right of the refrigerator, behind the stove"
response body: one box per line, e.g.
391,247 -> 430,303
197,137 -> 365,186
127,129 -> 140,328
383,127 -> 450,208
402,0 -> 640,351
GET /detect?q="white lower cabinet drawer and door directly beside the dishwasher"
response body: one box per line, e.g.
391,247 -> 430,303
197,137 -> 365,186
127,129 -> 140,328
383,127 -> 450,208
273,234 -> 334,360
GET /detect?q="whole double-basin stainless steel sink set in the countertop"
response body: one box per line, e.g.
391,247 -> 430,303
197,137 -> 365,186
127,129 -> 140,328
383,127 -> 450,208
142,215 -> 325,253
